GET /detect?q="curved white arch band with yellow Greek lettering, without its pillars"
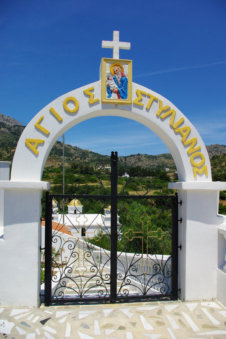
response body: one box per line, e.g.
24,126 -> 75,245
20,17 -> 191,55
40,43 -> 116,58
11,81 -> 212,182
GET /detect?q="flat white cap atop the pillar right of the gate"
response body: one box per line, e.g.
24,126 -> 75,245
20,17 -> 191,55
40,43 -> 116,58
168,181 -> 226,191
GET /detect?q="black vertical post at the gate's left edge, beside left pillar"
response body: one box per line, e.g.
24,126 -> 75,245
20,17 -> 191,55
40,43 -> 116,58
45,192 -> 52,306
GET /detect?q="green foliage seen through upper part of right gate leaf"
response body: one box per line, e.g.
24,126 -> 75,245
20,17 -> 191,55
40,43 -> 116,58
118,200 -> 171,254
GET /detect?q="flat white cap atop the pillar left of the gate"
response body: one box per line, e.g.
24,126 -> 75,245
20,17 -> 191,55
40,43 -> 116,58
0,180 -> 50,190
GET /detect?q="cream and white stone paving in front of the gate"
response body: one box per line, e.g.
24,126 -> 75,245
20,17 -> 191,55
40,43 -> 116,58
0,301 -> 226,339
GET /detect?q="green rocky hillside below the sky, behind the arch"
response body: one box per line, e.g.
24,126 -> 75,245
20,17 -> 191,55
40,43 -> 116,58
0,114 -> 226,181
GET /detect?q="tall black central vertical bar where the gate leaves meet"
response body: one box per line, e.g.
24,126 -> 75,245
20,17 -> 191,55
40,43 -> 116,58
110,152 -> 118,301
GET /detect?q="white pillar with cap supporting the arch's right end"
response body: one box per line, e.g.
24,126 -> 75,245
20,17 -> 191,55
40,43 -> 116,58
169,182 -> 226,300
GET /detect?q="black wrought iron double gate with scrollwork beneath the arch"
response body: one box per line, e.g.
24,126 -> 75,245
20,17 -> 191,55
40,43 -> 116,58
45,152 -> 178,305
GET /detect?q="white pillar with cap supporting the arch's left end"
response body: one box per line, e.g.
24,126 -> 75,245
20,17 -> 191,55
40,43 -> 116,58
0,181 -> 48,306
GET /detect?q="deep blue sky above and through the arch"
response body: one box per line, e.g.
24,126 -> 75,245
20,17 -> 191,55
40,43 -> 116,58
0,0 -> 226,155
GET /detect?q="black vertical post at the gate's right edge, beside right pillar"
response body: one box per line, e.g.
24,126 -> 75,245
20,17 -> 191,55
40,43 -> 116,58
171,194 -> 178,300
